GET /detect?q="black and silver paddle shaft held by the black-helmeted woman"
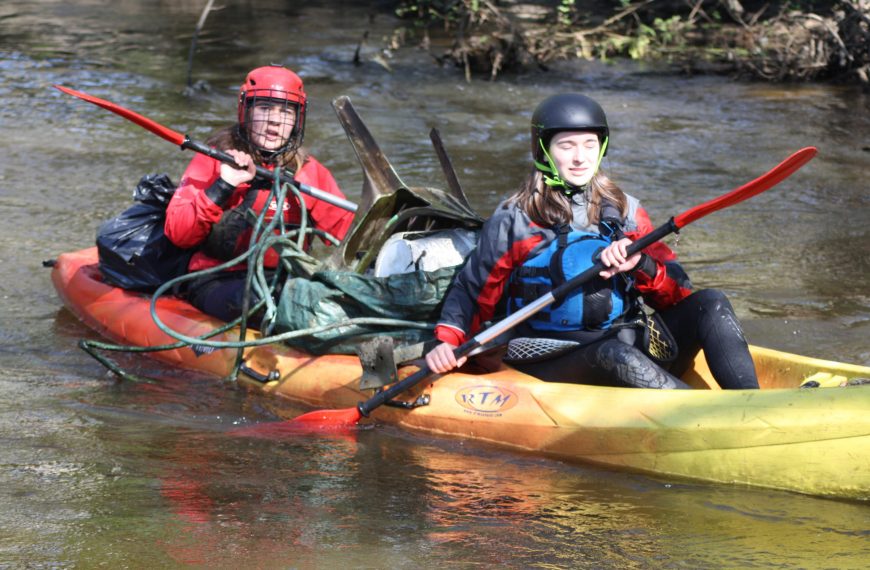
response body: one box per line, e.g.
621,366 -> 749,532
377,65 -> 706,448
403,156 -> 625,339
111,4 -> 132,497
357,218 -> 680,417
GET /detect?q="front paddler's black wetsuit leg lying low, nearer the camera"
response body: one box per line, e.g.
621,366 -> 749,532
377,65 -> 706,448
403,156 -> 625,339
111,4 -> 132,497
511,331 -> 690,389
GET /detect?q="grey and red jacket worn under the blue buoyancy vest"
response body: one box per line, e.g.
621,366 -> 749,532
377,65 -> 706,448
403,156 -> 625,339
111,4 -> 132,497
435,193 -> 692,346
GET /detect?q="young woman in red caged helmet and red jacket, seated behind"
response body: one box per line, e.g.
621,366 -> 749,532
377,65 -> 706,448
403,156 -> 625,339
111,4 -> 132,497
164,65 -> 353,321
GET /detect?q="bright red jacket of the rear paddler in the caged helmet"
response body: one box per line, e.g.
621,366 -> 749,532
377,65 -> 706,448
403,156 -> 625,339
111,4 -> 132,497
164,154 -> 353,272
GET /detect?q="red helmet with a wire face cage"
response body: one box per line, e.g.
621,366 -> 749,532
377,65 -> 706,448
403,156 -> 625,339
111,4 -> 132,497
239,65 -> 308,158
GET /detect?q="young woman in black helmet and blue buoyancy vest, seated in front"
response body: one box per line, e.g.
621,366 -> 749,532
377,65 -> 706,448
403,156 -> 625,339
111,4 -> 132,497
426,93 -> 758,389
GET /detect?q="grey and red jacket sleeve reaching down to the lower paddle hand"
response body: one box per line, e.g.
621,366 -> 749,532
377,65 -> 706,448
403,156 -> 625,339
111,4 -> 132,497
435,202 -> 543,345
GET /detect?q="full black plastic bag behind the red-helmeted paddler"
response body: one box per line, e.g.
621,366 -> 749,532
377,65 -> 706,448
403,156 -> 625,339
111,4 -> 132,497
97,174 -> 193,292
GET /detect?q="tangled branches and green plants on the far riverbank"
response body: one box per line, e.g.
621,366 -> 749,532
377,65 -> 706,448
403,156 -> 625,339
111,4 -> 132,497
392,0 -> 870,86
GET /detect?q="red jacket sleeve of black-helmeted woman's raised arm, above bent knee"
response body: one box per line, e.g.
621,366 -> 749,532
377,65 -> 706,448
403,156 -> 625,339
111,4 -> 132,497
626,207 -> 692,310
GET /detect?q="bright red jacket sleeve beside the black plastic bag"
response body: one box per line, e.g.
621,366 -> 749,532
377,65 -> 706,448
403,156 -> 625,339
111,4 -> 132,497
164,154 -> 233,248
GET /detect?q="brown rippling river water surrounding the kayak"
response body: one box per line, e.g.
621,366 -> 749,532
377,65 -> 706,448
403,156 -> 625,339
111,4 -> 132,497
0,0 -> 870,568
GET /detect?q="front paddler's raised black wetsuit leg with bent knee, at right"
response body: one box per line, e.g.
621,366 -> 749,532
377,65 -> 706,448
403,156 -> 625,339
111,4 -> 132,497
659,289 -> 758,390
